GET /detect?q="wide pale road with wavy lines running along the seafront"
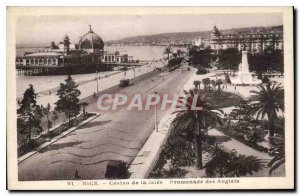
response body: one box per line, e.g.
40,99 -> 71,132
18,66 -> 192,180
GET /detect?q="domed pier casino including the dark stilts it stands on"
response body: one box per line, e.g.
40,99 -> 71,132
16,26 -> 133,75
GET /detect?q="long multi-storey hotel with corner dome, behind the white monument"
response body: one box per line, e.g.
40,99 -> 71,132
210,26 -> 283,54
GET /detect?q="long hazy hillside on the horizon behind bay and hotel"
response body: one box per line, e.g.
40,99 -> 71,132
105,25 -> 283,45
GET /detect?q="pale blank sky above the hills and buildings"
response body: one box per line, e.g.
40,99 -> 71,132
16,13 -> 283,44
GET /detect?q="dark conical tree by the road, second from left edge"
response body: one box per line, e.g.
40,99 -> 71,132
55,75 -> 81,126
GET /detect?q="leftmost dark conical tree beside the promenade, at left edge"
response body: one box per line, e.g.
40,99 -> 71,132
17,84 -> 42,145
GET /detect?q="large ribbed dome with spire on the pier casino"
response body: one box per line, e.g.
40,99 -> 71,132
78,25 -> 104,50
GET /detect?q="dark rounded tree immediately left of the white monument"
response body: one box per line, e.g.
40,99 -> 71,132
219,48 -> 241,71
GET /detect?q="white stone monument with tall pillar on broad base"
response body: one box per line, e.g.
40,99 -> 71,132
231,51 -> 262,85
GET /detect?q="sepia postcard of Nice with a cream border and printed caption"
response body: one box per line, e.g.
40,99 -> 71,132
7,7 -> 294,190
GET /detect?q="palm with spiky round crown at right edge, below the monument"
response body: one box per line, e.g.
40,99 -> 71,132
248,83 -> 284,143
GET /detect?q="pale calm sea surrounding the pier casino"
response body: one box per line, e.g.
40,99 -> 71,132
16,46 -> 165,97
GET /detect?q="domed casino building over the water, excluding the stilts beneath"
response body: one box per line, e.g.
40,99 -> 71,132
16,26 -> 134,68
